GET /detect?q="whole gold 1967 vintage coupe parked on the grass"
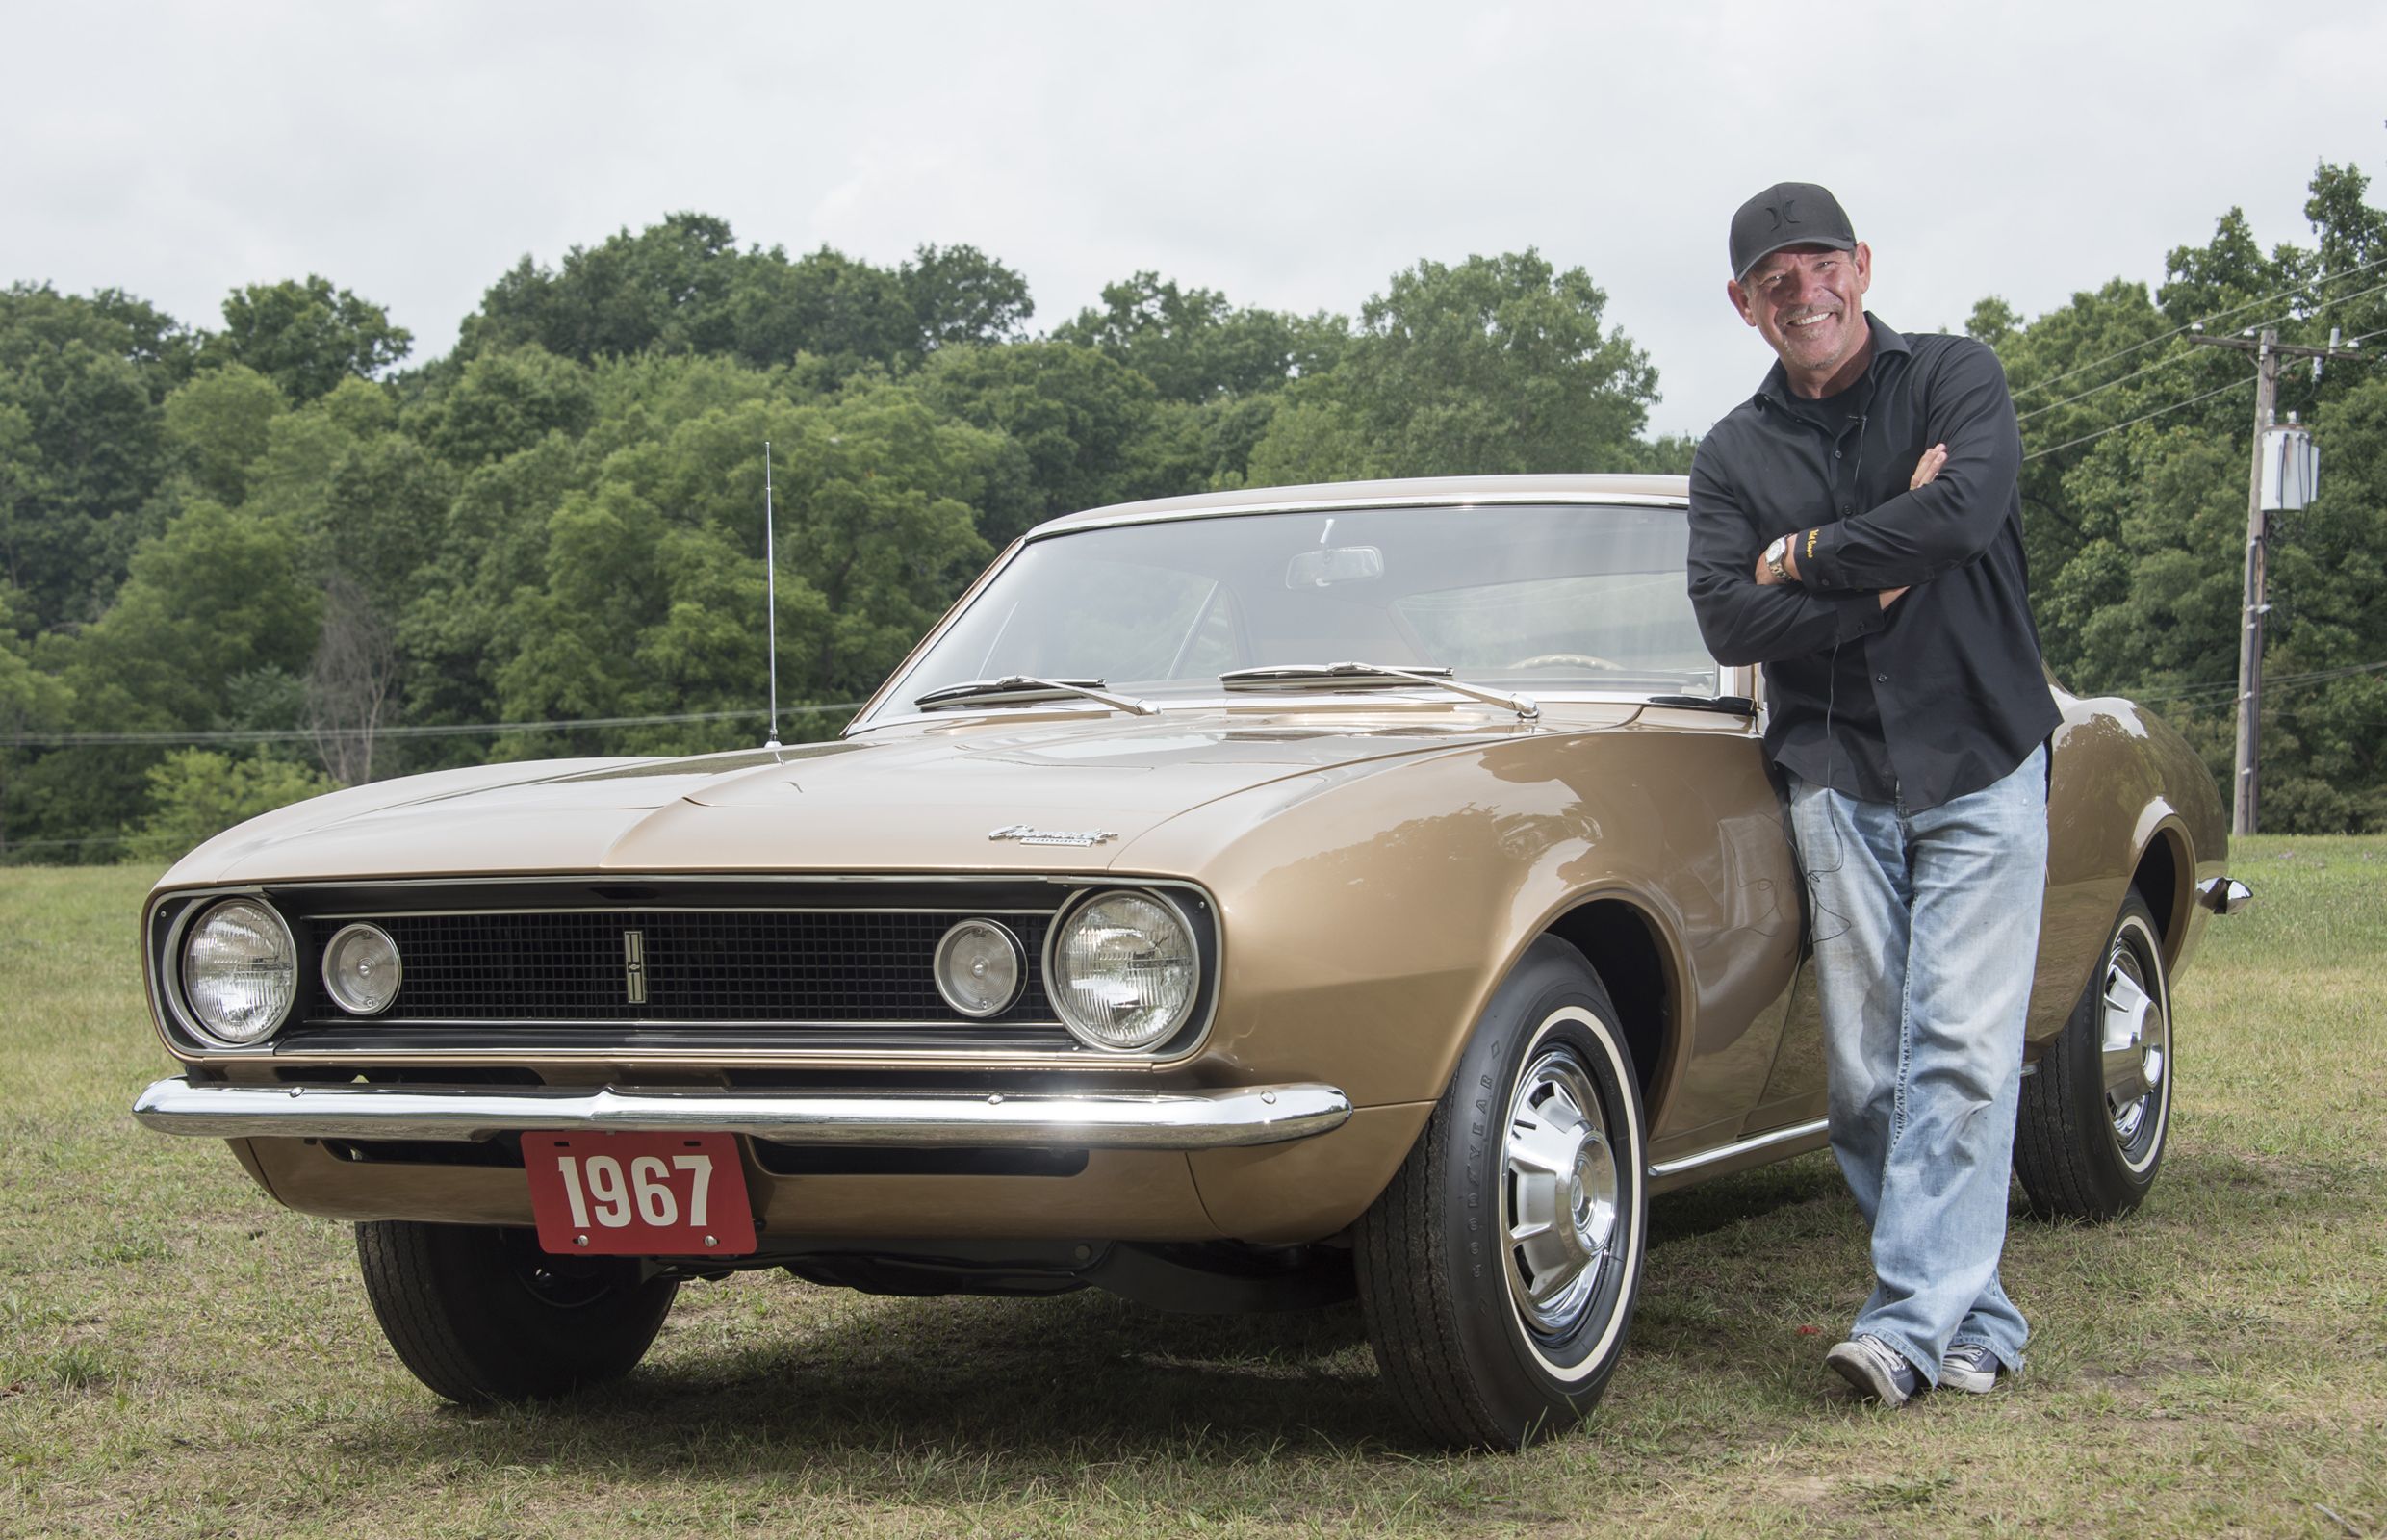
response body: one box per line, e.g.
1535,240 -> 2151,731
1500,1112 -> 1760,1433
136,475 -> 2244,1447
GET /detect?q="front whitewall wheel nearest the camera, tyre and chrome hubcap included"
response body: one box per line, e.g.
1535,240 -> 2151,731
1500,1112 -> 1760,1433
1356,938 -> 1650,1450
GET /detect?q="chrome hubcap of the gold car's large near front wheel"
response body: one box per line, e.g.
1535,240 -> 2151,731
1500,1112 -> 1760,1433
1502,1048 -> 1618,1332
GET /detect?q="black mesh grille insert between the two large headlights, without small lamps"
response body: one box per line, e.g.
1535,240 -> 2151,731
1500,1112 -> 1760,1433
291,910 -> 1053,1027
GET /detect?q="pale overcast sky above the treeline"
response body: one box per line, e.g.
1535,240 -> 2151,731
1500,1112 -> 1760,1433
0,0 -> 2387,432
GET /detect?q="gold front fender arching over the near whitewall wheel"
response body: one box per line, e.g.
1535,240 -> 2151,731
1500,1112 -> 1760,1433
1115,711 -> 1800,1137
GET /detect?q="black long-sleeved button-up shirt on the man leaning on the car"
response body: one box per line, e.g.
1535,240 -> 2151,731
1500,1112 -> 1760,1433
1690,313 -> 2060,809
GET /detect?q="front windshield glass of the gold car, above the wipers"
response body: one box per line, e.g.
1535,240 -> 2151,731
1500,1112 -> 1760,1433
884,506 -> 1719,714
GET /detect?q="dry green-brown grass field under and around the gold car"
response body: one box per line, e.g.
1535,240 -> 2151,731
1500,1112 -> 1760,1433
0,838 -> 2387,1540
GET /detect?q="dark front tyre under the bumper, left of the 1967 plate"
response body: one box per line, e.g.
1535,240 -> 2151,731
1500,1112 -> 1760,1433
356,1220 -> 680,1404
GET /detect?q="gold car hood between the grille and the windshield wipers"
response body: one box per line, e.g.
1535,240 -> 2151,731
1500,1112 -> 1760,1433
167,705 -> 1584,886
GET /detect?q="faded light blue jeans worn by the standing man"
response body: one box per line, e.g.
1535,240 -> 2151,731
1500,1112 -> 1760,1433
1790,747 -> 2048,1382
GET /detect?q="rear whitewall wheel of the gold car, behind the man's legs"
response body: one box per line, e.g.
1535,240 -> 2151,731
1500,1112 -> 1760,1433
2015,890 -> 2172,1220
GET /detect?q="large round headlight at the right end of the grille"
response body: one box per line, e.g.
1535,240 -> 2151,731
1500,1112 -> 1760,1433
1045,893 -> 1200,1053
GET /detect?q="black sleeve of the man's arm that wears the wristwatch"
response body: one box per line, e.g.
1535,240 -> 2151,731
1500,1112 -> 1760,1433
1794,344 -> 2022,590
